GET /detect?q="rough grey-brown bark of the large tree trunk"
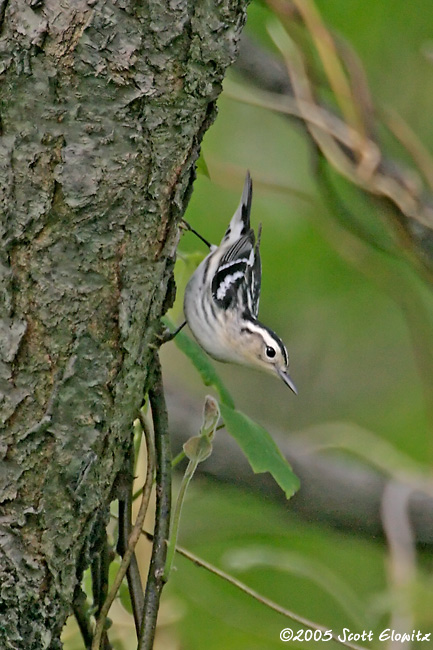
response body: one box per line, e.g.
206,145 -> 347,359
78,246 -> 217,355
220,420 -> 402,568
0,0 -> 246,650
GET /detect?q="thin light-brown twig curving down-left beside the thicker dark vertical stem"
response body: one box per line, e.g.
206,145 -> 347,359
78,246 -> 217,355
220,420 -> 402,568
92,410 -> 155,650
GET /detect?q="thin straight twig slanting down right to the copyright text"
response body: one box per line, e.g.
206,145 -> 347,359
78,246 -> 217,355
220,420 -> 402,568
142,530 -> 367,650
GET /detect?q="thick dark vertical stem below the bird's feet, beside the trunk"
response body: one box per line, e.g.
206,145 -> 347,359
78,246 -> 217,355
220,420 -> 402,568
137,354 -> 171,650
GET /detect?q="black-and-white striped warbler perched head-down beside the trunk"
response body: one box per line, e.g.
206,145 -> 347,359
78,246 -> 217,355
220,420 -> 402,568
184,172 -> 297,393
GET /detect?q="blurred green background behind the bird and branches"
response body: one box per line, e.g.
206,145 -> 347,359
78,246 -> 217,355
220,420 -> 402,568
65,0 -> 433,650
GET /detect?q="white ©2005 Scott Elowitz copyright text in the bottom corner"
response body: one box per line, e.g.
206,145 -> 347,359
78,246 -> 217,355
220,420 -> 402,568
280,627 -> 432,643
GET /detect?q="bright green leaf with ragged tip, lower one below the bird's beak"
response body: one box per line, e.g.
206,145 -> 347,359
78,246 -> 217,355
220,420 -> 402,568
220,402 -> 299,499
